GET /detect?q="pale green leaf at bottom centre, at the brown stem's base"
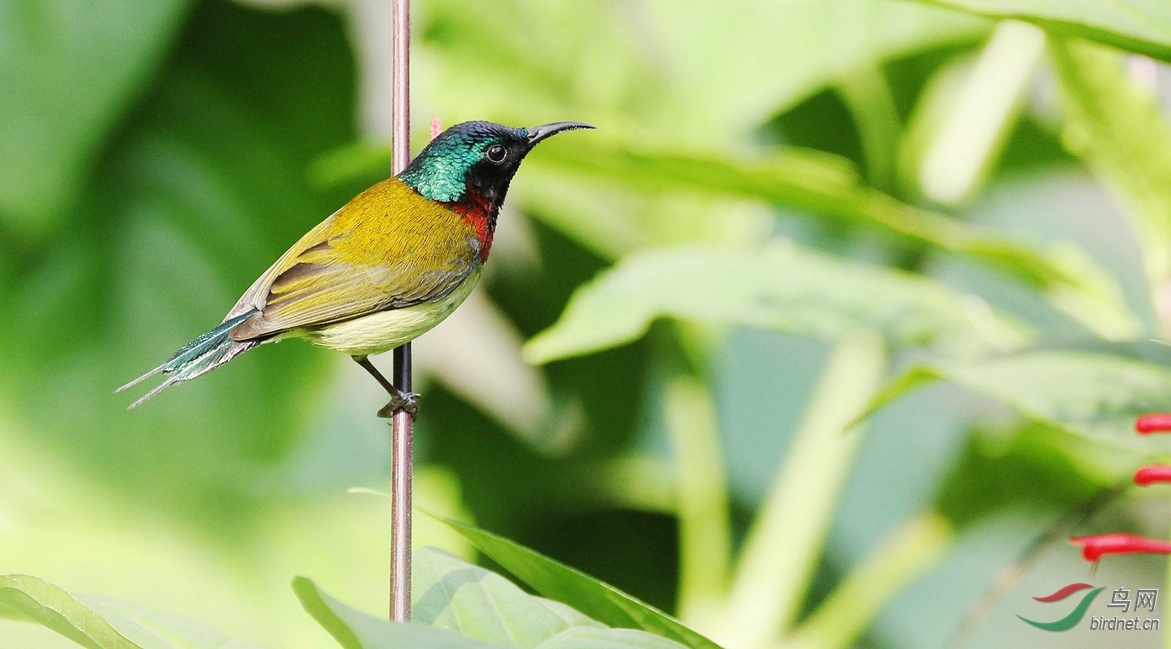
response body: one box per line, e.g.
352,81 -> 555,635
293,548 -> 683,649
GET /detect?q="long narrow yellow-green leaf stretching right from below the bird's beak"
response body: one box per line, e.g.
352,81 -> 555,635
537,137 -> 1141,340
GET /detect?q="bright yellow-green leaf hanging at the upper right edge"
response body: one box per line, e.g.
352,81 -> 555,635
1052,37 -> 1171,313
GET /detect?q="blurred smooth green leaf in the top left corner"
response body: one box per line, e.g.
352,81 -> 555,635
0,0 -> 190,231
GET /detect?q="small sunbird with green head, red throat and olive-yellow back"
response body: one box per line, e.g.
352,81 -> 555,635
117,122 -> 594,417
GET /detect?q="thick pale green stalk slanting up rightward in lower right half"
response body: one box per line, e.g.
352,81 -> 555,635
719,332 -> 886,649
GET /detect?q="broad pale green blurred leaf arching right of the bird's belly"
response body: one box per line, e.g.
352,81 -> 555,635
525,245 -> 1029,363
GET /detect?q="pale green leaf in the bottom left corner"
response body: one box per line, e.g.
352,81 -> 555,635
0,575 -> 263,649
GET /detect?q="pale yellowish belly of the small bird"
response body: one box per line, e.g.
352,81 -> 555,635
297,264 -> 480,356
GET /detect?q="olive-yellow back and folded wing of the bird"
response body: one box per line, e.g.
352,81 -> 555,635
223,176 -> 480,341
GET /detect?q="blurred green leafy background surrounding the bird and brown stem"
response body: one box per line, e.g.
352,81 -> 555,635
0,0 -> 1171,649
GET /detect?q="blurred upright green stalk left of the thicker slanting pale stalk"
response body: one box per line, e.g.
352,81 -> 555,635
664,373 -> 732,627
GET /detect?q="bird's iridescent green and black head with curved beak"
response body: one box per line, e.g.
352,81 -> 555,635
398,122 -> 594,209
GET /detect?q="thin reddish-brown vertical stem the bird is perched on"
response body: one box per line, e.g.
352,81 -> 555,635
390,0 -> 413,622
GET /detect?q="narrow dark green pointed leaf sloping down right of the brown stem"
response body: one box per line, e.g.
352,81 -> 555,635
436,517 -> 719,649
